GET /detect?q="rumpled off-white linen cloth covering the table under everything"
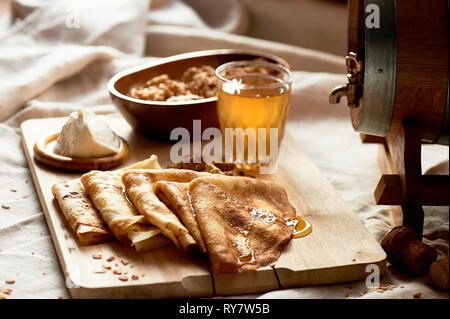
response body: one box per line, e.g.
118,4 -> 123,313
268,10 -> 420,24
0,0 -> 449,298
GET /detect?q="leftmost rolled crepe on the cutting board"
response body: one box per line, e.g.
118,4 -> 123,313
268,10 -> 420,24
52,179 -> 114,245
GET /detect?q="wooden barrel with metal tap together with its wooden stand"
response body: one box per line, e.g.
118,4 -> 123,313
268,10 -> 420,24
330,0 -> 450,238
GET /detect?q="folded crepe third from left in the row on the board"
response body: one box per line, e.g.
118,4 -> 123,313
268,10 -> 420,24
122,169 -> 211,252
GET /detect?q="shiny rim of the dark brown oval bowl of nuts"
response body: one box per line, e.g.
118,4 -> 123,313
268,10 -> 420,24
107,49 -> 292,106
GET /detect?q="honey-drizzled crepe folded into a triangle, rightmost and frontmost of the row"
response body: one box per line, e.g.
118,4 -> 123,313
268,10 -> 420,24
189,175 -> 295,274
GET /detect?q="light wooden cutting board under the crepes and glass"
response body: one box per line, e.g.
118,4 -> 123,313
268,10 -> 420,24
21,116 -> 386,298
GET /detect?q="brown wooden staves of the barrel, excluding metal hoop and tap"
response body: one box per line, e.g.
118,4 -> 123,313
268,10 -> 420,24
348,0 -> 449,142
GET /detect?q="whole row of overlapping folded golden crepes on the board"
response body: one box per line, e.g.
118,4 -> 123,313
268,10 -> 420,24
52,156 -> 295,274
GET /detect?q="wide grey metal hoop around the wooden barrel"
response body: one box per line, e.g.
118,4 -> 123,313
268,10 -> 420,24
357,0 -> 397,136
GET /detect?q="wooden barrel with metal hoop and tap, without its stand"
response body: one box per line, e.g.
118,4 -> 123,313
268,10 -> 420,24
330,0 -> 449,145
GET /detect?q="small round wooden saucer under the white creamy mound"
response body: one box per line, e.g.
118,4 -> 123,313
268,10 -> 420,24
33,132 -> 130,172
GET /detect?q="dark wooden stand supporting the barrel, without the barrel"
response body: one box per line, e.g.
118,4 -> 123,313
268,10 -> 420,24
361,119 -> 450,239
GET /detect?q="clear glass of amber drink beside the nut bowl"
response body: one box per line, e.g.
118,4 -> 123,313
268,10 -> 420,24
216,60 -> 292,173
